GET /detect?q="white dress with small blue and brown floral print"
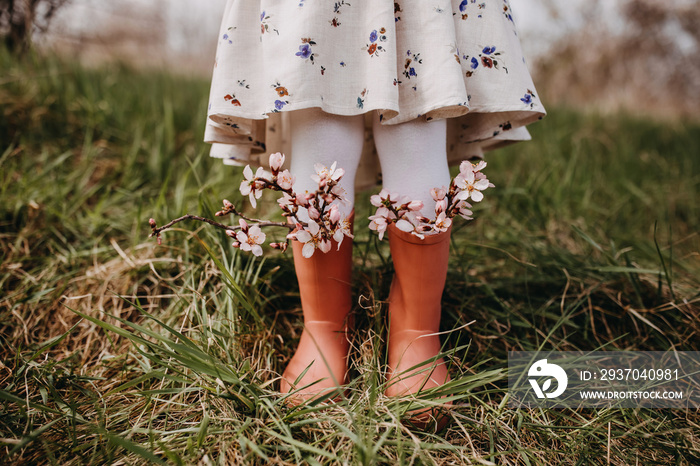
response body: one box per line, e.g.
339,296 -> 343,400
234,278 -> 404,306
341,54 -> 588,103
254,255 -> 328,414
205,0 -> 545,187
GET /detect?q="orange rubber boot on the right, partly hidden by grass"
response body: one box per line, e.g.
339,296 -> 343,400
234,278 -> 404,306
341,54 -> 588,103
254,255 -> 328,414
386,224 -> 451,427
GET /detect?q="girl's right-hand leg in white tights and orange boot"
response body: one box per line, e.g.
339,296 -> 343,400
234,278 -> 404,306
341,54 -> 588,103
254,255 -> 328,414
374,114 -> 450,416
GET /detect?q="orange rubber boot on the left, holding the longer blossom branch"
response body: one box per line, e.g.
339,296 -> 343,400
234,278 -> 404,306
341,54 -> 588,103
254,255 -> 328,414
280,213 -> 354,403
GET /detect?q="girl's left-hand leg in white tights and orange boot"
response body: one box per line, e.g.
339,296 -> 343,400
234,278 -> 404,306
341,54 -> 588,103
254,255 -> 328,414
280,109 -> 364,400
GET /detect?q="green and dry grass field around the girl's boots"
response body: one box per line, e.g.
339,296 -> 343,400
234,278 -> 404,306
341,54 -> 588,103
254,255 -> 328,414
0,52 -> 700,465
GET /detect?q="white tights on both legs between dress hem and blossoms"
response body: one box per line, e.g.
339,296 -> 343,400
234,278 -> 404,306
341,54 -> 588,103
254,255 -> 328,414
290,108 -> 450,218
